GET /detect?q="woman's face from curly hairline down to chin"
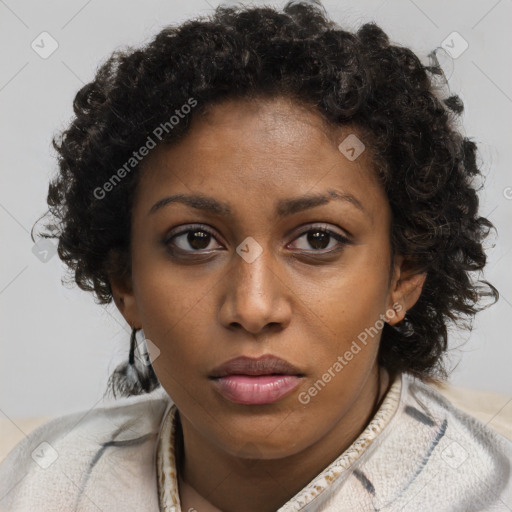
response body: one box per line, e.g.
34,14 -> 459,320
113,98 -> 412,459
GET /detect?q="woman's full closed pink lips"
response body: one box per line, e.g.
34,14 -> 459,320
210,354 -> 304,405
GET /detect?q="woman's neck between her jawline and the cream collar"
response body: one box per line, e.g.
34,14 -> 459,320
177,367 -> 391,512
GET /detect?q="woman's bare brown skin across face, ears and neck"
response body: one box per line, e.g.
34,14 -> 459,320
111,97 -> 425,512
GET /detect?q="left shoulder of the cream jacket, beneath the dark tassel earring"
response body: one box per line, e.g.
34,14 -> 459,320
0,388 -> 172,512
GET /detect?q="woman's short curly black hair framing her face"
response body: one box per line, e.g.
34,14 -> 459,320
31,2 -> 499,392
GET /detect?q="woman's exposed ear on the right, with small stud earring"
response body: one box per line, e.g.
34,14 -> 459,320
386,255 -> 427,325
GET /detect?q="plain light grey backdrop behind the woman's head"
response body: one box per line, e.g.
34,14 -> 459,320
0,0 -> 512,418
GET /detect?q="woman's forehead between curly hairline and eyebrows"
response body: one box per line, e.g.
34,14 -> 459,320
134,97 -> 385,222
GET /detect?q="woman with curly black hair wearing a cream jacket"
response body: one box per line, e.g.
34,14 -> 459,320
0,3 -> 512,512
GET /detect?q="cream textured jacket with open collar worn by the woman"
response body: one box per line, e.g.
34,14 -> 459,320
0,374 -> 512,512
